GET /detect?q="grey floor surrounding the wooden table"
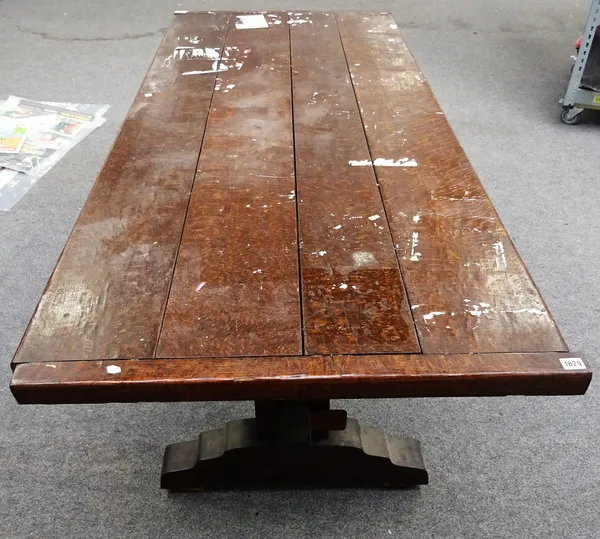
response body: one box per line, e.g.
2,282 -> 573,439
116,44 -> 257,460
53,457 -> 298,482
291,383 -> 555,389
0,0 -> 600,539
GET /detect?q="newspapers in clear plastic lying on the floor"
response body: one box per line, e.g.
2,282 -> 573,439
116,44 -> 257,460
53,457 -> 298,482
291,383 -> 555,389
0,96 -> 109,211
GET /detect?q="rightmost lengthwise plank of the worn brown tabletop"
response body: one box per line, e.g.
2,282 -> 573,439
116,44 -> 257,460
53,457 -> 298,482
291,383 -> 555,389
337,13 -> 567,353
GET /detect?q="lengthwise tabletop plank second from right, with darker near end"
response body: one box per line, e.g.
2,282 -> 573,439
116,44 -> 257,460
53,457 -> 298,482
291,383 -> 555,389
290,13 -> 420,354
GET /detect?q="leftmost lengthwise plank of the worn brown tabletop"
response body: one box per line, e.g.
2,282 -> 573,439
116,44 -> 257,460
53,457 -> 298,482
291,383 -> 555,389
14,13 -> 229,363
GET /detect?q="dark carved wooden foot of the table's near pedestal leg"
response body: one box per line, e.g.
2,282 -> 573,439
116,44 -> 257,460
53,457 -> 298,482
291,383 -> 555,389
161,419 -> 428,491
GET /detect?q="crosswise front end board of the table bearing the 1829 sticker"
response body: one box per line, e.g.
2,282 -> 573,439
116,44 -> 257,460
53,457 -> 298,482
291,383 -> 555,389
11,352 -> 592,404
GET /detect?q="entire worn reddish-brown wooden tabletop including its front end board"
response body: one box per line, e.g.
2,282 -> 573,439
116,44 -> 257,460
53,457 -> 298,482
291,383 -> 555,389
11,13 -> 591,403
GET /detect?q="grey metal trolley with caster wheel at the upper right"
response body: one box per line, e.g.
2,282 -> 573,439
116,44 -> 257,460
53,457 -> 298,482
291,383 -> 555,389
560,0 -> 600,125
